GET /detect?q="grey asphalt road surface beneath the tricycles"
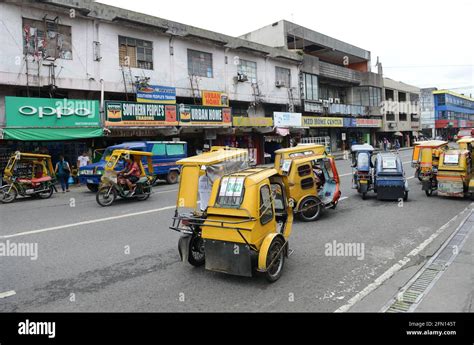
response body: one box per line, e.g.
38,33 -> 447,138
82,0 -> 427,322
0,151 -> 471,312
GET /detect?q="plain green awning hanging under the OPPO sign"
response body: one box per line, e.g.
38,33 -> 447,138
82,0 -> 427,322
3,128 -> 103,141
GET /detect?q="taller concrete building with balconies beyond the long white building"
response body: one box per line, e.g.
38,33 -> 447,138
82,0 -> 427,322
241,20 -> 383,150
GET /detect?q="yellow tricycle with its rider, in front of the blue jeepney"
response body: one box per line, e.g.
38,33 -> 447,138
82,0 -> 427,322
96,150 -> 153,206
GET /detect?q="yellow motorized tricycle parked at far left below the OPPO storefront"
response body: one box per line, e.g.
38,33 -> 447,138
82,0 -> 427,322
0,151 -> 55,203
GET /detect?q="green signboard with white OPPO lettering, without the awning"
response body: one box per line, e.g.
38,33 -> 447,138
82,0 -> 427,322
5,96 -> 100,128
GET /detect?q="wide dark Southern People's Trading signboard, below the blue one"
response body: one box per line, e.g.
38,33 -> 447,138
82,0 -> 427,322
105,101 -> 179,127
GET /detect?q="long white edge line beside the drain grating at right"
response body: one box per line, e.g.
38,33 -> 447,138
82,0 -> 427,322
334,203 -> 474,313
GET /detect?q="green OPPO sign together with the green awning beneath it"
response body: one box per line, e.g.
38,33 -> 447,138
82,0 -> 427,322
4,97 -> 102,140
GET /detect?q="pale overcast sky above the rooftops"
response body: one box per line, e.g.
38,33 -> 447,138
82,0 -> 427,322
100,0 -> 474,96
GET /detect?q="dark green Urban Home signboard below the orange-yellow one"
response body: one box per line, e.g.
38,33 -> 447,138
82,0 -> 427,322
178,104 -> 232,127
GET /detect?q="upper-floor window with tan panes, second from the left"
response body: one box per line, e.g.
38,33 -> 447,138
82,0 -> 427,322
119,36 -> 153,69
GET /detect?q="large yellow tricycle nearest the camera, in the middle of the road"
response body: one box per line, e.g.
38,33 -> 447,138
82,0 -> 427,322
171,168 -> 293,282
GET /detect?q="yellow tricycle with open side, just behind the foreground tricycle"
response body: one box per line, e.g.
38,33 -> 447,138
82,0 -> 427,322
275,144 -> 341,222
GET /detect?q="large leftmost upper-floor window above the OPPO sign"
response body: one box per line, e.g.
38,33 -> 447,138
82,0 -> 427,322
23,18 -> 72,60
